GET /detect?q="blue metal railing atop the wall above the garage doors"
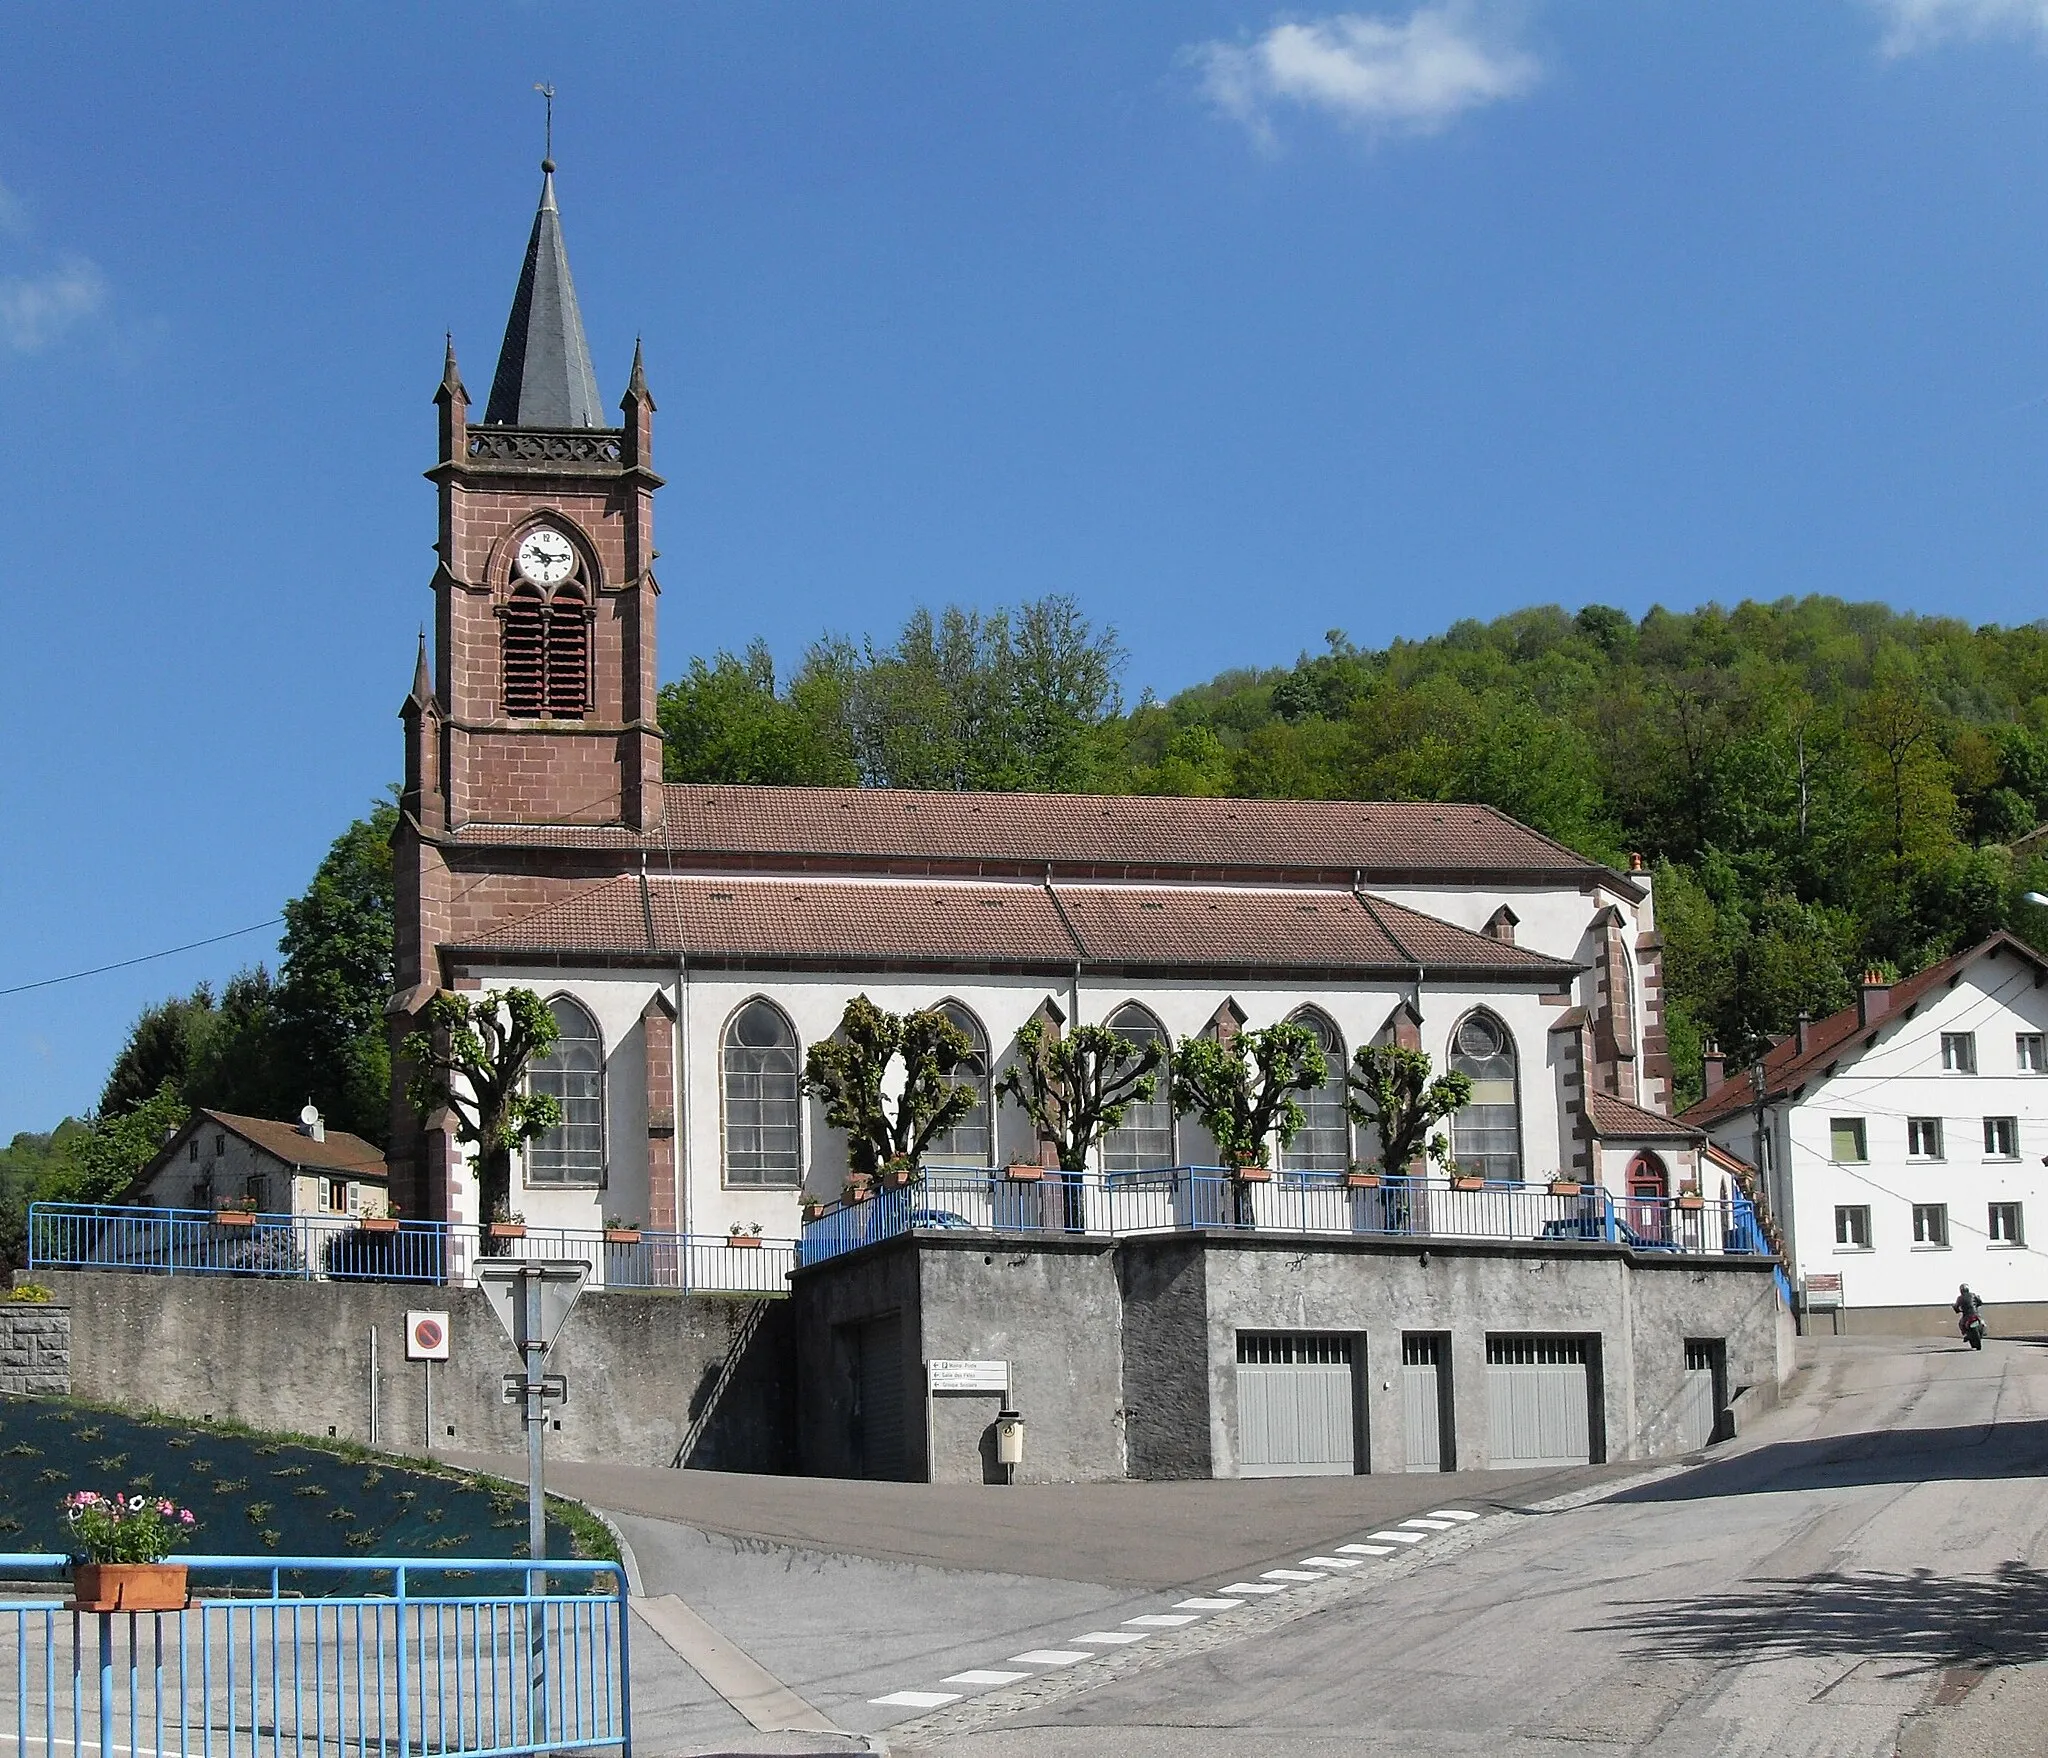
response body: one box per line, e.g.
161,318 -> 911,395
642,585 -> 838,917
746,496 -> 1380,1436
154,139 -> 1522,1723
797,1166 -> 1769,1264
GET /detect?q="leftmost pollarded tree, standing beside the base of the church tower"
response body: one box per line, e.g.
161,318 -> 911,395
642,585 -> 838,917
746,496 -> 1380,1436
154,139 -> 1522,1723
399,990 -> 561,1221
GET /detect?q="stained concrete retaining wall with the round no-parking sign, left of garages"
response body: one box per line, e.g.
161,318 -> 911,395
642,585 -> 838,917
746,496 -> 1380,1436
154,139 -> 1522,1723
39,1272 -> 797,1471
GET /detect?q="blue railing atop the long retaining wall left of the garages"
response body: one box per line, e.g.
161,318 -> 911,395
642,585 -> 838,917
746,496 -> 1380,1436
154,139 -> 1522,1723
29,1203 -> 797,1295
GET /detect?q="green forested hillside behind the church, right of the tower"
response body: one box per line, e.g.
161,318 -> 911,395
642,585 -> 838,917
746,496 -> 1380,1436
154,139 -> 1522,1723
662,598 -> 2048,1092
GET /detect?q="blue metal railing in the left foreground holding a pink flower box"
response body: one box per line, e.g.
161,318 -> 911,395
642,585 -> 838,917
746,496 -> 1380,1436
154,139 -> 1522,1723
0,1553 -> 633,1758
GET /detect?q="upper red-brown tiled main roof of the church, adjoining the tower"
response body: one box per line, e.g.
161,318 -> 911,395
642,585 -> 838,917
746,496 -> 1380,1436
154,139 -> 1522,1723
446,783 -> 1606,881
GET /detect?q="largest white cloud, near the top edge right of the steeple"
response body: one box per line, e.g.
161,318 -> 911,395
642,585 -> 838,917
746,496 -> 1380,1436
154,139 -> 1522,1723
1188,0 -> 1540,141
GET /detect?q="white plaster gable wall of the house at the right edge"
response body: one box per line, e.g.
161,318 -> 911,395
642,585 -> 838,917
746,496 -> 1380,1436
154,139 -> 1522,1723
1761,959 -> 2048,1307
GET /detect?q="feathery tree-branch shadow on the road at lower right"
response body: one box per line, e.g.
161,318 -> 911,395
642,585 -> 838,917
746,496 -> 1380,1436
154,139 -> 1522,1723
1591,1563 -> 2048,1666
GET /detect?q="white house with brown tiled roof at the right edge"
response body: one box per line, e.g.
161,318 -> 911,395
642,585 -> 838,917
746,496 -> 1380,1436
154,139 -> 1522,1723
1683,934 -> 2048,1328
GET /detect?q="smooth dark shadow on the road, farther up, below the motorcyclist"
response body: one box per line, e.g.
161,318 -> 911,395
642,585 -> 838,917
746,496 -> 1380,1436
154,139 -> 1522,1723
1612,1420 -> 2048,1502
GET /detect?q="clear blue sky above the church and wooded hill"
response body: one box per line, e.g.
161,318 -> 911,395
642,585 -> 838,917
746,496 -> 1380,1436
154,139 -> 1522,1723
0,0 -> 2048,1137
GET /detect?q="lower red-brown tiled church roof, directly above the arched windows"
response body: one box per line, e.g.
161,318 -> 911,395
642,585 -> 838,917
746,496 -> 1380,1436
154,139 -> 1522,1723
449,875 -> 1575,981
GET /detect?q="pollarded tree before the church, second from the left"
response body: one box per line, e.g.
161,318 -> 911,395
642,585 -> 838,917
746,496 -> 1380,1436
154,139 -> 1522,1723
803,996 -> 979,1178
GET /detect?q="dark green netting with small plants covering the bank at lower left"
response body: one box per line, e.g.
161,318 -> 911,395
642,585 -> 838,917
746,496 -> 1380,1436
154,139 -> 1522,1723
0,1397 -> 584,1594
